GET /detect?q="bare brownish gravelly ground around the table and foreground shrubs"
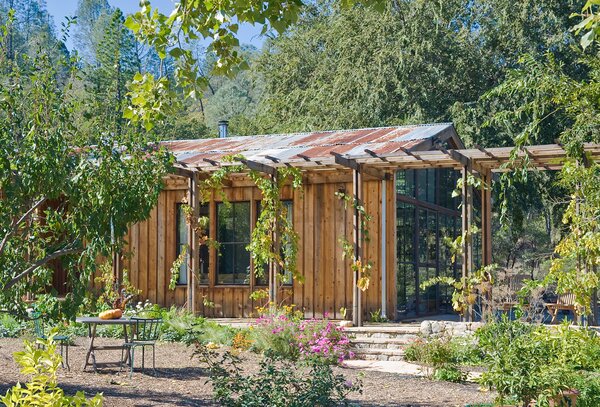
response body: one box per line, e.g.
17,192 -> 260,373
0,338 -> 491,407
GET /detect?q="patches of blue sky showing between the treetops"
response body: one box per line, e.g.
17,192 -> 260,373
47,0 -> 264,49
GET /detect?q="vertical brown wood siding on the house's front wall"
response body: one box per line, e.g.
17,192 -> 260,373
122,172 -> 396,318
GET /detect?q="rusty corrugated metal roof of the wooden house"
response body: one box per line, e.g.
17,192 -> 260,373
162,123 -> 453,167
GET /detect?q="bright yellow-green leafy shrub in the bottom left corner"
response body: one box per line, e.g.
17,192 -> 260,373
0,335 -> 102,407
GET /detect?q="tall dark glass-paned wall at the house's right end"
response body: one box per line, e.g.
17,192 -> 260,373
396,169 -> 460,318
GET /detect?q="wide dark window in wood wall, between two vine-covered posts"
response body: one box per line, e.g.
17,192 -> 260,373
217,202 -> 250,284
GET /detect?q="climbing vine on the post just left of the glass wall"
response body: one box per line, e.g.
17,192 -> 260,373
335,191 -> 373,291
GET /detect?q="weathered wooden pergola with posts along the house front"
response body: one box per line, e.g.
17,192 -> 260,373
166,124 -> 600,326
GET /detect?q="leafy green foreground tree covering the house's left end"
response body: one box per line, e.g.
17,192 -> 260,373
0,18 -> 171,316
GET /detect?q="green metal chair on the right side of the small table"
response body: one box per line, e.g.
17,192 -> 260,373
121,317 -> 162,378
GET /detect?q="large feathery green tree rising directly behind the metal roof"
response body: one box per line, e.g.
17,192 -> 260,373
248,0 -> 576,135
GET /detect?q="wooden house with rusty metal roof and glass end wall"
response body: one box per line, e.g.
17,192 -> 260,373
98,124 -> 596,320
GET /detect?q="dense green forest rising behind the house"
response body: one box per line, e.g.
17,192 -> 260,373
0,0 -> 598,280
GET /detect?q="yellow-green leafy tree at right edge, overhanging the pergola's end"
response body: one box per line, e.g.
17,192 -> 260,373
487,2 -> 600,322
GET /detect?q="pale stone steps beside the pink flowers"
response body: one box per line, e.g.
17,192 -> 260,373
345,325 -> 419,360
